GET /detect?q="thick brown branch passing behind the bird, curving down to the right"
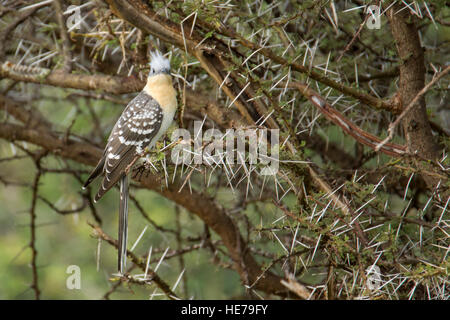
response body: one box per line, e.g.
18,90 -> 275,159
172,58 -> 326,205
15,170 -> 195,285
0,117 -> 302,296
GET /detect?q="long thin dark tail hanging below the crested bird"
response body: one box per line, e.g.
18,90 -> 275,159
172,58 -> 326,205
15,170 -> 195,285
118,174 -> 128,274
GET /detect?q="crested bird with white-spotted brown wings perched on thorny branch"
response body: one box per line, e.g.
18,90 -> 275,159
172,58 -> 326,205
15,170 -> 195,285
83,52 -> 177,274
